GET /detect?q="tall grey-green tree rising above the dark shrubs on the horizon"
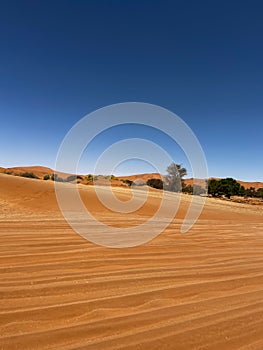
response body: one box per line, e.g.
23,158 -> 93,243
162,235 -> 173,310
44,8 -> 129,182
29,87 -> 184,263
164,163 -> 187,192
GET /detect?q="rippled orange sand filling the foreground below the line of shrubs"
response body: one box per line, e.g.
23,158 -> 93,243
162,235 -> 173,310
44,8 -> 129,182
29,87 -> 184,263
0,174 -> 263,350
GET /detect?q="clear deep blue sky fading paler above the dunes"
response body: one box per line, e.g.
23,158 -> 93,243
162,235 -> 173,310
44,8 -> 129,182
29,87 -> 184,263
0,0 -> 263,181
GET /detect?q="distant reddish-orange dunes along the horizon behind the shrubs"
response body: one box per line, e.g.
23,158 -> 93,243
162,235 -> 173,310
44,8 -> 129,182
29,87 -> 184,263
0,166 -> 263,190
